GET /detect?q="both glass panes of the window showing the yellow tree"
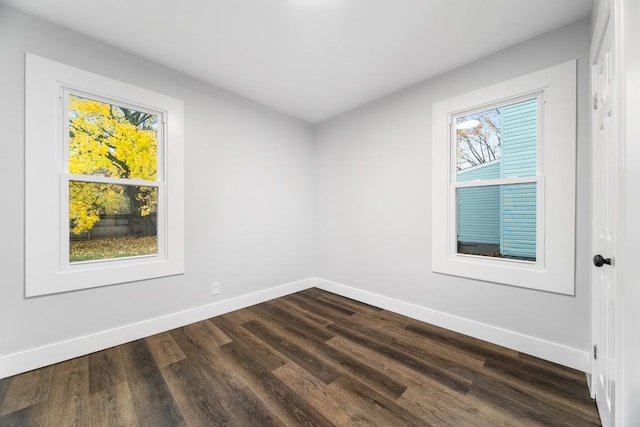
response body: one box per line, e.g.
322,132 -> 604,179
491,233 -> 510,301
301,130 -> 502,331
67,93 -> 158,263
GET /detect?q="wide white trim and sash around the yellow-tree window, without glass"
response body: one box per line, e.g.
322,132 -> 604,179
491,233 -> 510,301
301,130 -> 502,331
25,53 -> 184,297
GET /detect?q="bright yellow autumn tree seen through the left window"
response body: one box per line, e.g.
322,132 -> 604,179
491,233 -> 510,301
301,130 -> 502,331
69,95 -> 158,234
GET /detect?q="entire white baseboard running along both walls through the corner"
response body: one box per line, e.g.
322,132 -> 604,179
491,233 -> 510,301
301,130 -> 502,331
0,278 -> 590,379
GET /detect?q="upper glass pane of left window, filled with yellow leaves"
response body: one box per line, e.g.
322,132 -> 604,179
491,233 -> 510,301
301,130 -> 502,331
69,95 -> 158,181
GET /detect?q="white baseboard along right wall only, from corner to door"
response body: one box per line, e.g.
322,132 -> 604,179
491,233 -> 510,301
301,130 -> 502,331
315,278 -> 589,372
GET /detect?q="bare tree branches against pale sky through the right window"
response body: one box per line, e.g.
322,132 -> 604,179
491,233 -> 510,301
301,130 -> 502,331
456,109 -> 501,171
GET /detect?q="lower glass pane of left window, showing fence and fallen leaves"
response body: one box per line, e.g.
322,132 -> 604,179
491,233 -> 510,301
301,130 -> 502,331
69,181 -> 158,263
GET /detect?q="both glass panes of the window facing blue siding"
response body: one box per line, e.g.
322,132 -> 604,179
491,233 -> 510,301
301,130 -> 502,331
454,97 -> 538,261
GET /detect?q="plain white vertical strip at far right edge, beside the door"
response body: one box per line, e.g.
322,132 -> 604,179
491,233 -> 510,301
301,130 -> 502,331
614,0 -> 640,426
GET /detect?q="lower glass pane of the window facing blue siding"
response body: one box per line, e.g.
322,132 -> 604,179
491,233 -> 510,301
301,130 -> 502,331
456,183 -> 537,261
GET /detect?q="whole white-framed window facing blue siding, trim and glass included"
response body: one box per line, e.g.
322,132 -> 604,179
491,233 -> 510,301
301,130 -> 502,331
432,61 -> 576,294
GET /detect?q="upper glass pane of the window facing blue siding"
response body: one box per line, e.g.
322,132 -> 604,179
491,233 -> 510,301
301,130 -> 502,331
455,98 -> 538,181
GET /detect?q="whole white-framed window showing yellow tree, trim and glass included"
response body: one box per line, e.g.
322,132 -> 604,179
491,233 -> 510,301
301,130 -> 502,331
25,54 -> 184,296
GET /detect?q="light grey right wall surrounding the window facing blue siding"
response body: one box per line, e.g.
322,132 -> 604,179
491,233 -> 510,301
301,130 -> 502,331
316,20 -> 591,358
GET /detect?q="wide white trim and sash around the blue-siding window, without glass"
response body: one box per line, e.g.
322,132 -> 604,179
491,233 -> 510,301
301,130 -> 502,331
432,61 -> 576,295
